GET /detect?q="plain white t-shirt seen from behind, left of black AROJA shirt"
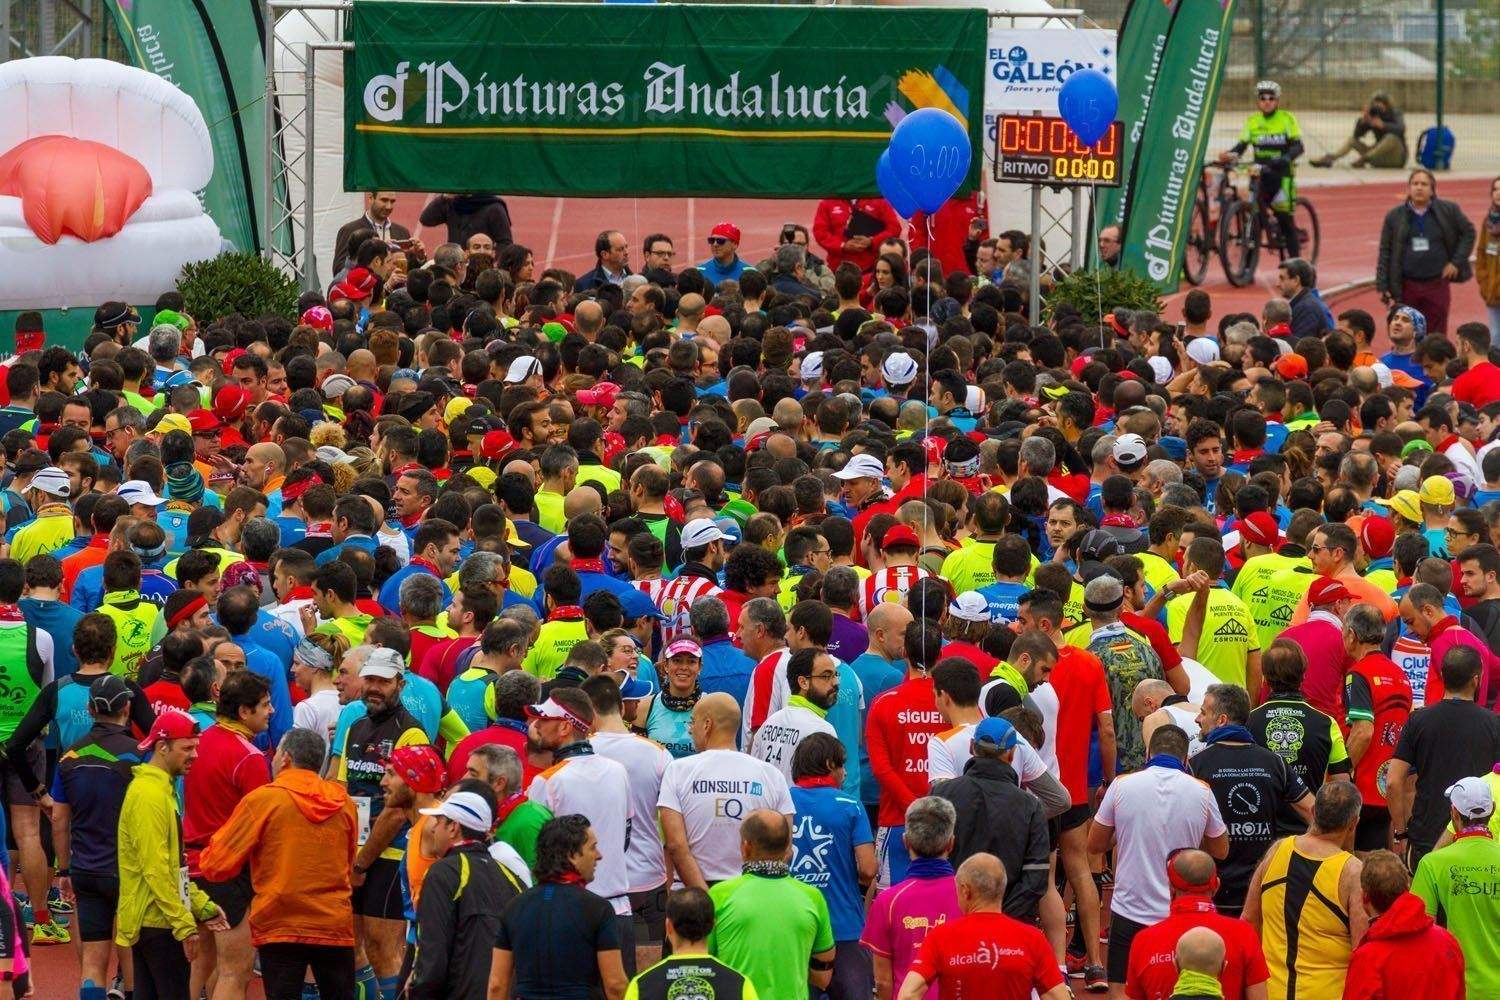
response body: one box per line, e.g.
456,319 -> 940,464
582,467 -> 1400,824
1094,768 -> 1226,924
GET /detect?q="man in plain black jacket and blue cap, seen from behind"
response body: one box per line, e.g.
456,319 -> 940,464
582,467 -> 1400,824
932,718 -> 1050,922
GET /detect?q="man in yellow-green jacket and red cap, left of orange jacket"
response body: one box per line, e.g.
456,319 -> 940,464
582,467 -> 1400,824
114,711 -> 230,1000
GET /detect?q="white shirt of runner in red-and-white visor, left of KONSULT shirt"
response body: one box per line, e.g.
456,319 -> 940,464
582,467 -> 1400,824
527,754 -> 633,916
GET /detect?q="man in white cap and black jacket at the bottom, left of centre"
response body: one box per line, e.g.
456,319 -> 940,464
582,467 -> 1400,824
407,778 -> 525,1000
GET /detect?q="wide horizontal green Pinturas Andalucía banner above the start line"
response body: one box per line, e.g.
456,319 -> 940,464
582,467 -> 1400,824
344,0 -> 986,198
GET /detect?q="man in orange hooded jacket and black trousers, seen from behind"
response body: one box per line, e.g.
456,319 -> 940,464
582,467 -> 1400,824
198,729 -> 359,1000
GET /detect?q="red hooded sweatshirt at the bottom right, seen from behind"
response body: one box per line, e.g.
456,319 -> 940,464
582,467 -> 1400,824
1344,892 -> 1464,1000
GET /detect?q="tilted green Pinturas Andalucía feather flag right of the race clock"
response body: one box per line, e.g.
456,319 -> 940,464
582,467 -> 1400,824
1121,0 -> 1235,292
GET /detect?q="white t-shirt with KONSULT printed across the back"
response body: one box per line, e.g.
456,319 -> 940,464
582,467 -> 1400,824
657,750 -> 797,882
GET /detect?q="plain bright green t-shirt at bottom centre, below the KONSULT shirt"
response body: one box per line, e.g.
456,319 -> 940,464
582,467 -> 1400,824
708,876 -> 834,1000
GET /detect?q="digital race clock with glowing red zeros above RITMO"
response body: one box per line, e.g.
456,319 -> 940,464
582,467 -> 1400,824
995,114 -> 1122,187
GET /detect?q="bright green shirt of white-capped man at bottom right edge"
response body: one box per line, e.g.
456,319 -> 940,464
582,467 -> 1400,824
1412,834 -> 1500,997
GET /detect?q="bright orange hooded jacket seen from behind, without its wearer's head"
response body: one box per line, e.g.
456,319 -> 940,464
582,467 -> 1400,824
198,768 -> 359,948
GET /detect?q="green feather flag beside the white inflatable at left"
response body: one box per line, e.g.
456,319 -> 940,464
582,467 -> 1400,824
102,0 -> 266,252
